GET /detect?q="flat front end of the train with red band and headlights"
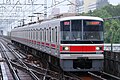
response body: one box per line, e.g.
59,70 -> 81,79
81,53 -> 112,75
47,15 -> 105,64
60,16 -> 104,71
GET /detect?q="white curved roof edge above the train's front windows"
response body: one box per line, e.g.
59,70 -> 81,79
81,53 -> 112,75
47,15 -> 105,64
60,16 -> 103,21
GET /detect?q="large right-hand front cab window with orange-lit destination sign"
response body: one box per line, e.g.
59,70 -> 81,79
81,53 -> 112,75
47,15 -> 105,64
83,20 -> 103,41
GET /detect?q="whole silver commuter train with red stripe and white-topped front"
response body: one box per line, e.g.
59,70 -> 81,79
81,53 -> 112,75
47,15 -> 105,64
11,16 -> 104,72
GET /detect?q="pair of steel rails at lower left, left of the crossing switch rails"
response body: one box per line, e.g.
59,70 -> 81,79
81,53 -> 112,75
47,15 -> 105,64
0,41 -> 39,80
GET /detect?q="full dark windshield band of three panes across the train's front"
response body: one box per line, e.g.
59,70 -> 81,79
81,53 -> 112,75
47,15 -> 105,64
60,19 -> 103,44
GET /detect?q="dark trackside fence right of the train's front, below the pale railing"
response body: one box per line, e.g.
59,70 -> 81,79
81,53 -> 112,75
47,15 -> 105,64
104,51 -> 120,77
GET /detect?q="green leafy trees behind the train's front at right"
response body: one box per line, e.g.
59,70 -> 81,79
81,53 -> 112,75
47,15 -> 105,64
81,4 -> 120,43
